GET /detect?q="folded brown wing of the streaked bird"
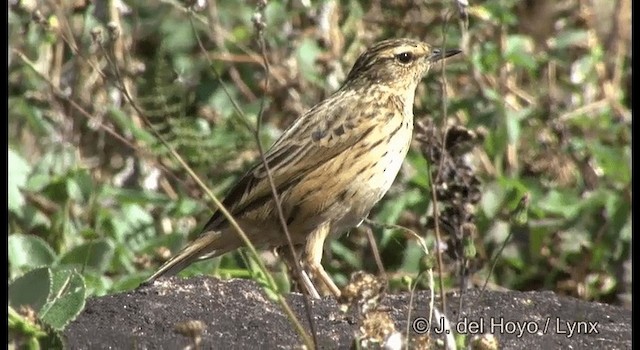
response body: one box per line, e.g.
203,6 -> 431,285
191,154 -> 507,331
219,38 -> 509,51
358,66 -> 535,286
203,91 -> 375,232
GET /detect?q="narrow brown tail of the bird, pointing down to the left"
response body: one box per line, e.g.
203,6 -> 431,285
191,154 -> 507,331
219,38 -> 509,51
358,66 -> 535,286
141,232 -> 224,286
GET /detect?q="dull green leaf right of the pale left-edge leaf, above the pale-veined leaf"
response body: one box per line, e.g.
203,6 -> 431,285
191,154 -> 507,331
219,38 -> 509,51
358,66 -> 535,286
60,239 -> 114,272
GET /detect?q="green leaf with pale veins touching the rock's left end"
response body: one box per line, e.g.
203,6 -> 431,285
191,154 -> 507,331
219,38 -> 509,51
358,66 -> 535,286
39,269 -> 86,330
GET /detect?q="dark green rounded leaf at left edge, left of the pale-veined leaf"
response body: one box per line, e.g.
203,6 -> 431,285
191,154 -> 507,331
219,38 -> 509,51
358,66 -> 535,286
9,267 -> 52,312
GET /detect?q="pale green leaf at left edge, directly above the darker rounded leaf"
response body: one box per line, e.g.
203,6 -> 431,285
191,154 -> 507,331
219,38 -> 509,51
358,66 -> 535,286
7,234 -> 56,269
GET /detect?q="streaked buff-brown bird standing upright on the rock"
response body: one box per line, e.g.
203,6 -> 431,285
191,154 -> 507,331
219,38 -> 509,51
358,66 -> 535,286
145,39 -> 460,297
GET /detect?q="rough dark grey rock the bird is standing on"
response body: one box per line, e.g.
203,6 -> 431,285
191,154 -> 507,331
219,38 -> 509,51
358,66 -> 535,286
64,277 -> 631,349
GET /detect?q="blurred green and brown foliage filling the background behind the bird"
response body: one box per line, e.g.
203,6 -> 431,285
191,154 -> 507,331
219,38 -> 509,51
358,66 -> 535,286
8,0 -> 631,344
